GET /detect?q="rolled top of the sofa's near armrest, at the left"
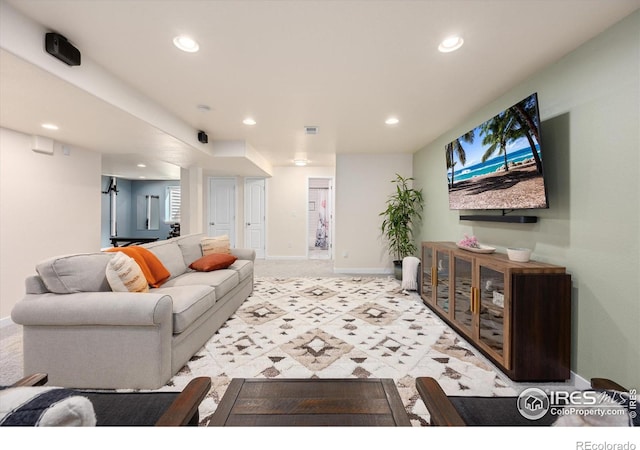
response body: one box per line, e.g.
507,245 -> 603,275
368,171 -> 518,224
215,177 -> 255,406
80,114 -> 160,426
11,292 -> 173,326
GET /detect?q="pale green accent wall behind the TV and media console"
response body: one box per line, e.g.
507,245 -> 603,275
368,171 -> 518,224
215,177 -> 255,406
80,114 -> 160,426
413,11 -> 640,389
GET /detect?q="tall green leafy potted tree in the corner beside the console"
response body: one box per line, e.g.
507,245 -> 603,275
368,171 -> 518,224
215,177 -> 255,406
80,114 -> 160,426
380,174 -> 423,280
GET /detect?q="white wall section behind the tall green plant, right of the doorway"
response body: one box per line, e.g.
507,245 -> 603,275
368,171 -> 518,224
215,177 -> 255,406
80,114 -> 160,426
334,154 -> 413,273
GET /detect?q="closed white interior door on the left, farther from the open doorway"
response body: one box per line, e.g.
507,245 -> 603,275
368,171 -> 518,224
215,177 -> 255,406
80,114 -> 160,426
207,178 -> 236,247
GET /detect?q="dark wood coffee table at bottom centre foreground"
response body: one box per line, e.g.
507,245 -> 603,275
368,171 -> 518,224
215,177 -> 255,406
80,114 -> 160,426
209,378 -> 411,426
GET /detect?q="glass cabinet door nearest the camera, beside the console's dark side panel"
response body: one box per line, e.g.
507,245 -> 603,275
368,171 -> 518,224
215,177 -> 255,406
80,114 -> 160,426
477,266 -> 508,361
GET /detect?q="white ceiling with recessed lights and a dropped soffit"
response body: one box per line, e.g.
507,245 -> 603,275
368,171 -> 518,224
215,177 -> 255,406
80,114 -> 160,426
0,0 -> 640,179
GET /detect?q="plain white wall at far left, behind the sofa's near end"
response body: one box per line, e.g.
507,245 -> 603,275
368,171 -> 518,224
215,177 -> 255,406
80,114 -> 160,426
0,128 -> 101,319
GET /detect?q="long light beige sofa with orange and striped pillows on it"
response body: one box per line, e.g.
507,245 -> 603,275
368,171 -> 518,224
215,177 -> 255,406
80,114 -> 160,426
11,234 -> 255,389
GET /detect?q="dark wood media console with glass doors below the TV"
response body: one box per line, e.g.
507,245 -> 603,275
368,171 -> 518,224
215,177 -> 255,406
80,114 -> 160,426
420,242 -> 571,381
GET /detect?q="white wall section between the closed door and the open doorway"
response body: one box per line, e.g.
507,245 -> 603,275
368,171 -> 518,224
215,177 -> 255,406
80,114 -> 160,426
266,166 -> 335,259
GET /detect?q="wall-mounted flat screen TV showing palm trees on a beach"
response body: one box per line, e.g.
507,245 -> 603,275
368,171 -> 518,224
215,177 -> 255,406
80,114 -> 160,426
445,93 -> 548,210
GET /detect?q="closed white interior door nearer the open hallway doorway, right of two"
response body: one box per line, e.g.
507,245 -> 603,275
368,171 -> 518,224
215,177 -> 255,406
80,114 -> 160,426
244,178 -> 265,258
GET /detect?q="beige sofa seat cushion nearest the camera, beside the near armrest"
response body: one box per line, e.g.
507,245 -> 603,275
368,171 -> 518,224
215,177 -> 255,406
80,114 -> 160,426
151,284 -> 216,334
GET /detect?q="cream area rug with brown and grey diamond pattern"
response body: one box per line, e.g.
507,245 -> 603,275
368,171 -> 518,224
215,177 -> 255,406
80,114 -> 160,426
163,277 -> 516,426
